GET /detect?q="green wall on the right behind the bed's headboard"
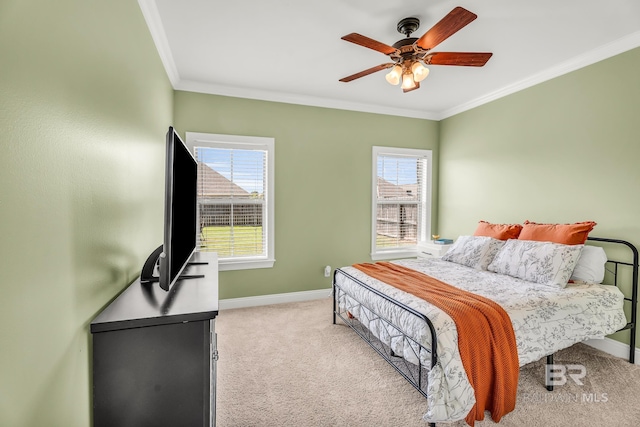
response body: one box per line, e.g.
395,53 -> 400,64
439,48 -> 640,348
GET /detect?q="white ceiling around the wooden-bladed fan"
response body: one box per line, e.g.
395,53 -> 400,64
138,0 -> 640,120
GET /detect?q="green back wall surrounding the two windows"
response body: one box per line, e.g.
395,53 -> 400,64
175,91 -> 438,299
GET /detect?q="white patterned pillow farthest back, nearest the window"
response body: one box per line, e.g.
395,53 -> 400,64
442,236 -> 504,270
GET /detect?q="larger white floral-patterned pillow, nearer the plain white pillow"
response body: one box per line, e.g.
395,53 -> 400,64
487,239 -> 584,288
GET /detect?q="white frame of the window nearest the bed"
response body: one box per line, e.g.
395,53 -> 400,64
371,146 -> 433,261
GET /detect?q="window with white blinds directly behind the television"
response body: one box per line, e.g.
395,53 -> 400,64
187,132 -> 275,271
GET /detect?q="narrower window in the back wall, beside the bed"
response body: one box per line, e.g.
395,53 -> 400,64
371,147 -> 431,260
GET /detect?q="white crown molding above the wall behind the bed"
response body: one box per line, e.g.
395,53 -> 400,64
436,31 -> 640,120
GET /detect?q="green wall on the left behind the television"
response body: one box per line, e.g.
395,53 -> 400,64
0,0 -> 173,427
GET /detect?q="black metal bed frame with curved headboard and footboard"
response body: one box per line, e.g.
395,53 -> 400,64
333,237 -> 639,427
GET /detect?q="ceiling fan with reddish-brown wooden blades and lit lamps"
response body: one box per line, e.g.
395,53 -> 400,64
340,7 -> 493,93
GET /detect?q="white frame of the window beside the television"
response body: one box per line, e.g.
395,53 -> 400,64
186,132 -> 276,271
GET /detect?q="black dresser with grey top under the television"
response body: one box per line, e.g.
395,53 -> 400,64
91,252 -> 218,427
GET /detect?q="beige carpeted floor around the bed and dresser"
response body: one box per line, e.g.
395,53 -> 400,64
216,298 -> 640,427
